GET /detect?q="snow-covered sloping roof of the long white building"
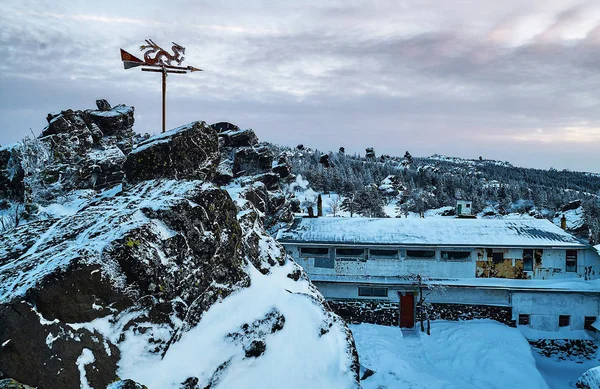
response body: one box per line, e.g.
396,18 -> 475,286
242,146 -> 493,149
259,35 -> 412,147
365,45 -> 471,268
277,217 -> 587,248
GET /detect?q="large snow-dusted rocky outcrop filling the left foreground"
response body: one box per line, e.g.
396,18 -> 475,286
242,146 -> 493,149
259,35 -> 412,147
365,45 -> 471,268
0,107 -> 359,389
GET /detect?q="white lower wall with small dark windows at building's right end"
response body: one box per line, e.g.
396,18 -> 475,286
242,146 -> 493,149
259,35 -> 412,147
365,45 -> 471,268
512,292 -> 600,331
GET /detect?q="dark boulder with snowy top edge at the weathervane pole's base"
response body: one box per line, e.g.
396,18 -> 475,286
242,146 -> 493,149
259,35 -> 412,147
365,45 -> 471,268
123,122 -> 220,185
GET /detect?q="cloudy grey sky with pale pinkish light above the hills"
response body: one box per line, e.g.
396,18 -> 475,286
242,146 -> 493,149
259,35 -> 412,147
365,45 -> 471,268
0,0 -> 600,172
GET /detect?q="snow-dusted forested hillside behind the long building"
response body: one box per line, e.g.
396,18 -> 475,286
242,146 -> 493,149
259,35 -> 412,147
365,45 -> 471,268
271,145 -> 600,243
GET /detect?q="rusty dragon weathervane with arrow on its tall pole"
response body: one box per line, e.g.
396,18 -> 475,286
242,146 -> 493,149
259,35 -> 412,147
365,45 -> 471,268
121,39 -> 202,132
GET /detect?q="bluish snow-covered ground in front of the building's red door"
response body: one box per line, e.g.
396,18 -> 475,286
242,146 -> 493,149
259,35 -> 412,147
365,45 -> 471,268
350,320 -> 548,389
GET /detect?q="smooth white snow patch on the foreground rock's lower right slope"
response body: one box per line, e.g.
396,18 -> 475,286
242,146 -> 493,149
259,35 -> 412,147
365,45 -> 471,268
118,262 -> 355,389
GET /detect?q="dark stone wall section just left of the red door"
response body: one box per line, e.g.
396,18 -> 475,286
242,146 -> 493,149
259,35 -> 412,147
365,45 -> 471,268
328,300 -> 399,326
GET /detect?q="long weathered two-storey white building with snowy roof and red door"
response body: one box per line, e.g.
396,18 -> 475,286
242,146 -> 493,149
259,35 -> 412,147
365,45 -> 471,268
277,218 -> 600,331
